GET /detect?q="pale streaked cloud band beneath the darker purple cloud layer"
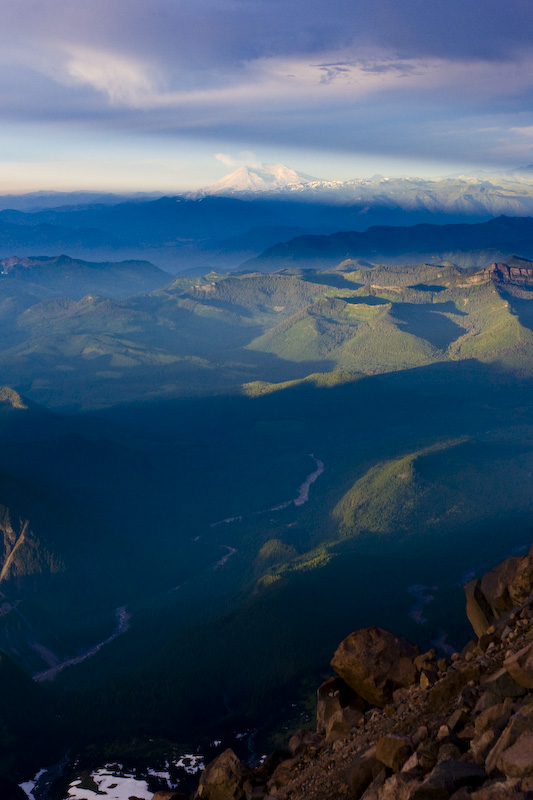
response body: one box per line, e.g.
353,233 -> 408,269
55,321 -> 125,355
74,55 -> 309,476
0,39 -> 533,171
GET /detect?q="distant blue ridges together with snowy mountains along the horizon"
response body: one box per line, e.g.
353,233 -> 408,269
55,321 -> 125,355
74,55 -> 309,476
0,164 -> 533,274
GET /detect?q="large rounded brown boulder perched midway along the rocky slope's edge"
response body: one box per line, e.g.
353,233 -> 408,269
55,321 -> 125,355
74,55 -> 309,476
331,626 -> 418,708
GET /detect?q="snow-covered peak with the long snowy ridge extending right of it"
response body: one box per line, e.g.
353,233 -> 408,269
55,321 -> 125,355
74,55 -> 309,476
195,164 -> 533,217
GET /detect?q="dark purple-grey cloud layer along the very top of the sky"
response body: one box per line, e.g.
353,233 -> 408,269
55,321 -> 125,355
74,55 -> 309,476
4,0 -> 533,74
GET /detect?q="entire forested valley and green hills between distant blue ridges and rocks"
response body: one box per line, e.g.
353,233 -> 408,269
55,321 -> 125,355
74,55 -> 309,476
0,226 -> 533,800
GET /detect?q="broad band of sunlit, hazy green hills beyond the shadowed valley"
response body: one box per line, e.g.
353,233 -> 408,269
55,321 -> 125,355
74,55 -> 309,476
0,260 -> 533,408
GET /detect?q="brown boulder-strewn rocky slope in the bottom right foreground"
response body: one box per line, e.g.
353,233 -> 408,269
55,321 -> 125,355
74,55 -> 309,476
187,548 -> 533,800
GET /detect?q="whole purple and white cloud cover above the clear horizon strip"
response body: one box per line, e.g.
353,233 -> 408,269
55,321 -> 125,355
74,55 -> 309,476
0,0 -> 533,177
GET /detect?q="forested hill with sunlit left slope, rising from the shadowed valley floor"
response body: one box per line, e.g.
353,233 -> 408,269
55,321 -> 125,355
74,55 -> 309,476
333,438 -> 533,539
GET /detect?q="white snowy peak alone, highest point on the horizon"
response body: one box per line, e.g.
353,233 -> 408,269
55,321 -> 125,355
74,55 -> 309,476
201,164 -> 317,195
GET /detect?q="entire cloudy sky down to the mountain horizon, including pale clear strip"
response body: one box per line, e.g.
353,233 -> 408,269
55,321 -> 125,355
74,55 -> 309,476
0,0 -> 533,194
